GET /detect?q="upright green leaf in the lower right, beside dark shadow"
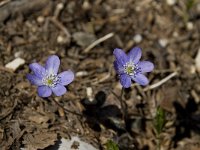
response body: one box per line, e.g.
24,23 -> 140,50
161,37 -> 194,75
154,107 -> 165,135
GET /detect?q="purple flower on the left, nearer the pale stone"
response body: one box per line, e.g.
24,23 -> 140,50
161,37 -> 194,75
27,55 -> 74,97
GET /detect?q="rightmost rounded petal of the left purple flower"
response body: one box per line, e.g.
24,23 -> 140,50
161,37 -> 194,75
58,70 -> 74,85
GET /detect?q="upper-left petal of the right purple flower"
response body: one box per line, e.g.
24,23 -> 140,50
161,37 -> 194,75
113,48 -> 127,65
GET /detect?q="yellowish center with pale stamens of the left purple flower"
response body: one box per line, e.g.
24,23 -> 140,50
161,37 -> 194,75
42,74 -> 60,87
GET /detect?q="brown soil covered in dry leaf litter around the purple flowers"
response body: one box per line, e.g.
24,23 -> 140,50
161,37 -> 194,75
0,0 -> 200,150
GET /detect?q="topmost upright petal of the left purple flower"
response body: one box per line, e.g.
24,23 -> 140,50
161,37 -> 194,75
45,55 -> 60,74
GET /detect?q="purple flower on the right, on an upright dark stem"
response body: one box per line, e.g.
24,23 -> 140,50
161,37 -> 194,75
113,47 -> 154,88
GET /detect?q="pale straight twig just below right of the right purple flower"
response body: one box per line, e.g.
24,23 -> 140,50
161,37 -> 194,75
144,72 -> 178,91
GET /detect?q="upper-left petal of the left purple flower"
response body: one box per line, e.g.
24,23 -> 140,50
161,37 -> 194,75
29,63 -> 45,78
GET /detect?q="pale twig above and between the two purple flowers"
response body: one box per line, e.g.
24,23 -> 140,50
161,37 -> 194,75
83,33 -> 114,53
